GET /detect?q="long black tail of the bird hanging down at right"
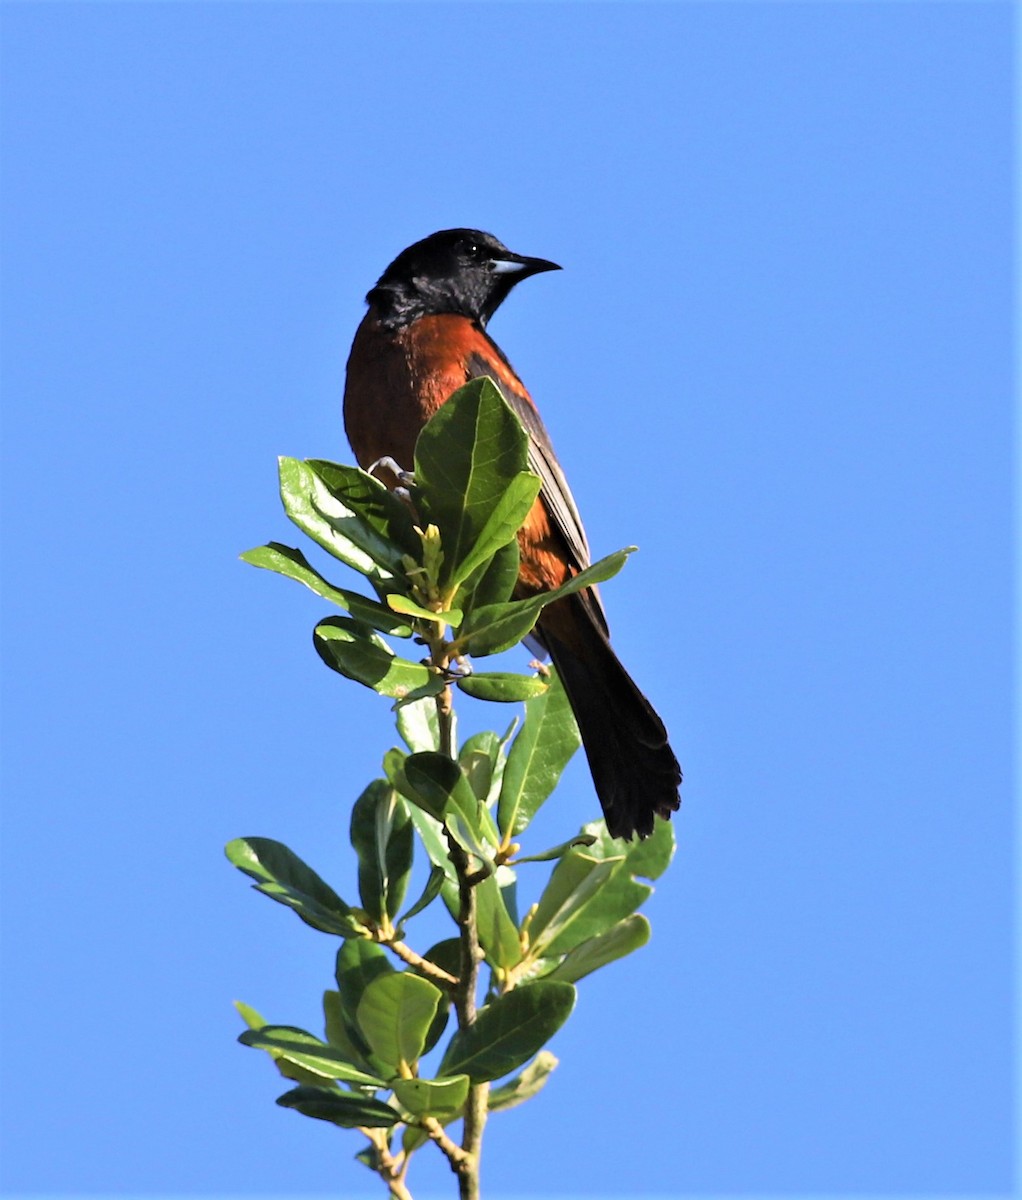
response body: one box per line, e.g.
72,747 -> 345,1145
539,594 -> 681,839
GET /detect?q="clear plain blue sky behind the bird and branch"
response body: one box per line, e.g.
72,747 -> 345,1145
2,2 -> 1012,1196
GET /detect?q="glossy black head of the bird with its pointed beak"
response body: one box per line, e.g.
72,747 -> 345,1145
366,229 -> 560,326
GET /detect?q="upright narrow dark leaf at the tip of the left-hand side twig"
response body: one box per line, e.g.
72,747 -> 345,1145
351,779 -> 415,925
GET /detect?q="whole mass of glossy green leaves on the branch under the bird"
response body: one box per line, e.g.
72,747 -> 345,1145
233,380 -> 674,1181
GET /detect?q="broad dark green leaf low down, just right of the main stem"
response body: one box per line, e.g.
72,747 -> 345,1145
438,979 -> 575,1084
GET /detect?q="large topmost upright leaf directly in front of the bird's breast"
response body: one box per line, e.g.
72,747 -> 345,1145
415,378 -> 539,586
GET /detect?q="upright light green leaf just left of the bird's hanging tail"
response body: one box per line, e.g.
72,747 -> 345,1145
497,668 -> 582,836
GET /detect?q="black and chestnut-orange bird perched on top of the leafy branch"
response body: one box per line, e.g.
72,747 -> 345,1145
344,229 -> 681,841
